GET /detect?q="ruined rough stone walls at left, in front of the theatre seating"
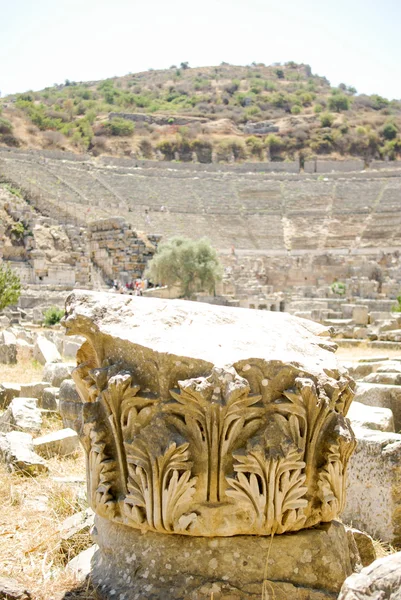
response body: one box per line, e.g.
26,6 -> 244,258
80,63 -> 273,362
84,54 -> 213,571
0,183 -> 160,289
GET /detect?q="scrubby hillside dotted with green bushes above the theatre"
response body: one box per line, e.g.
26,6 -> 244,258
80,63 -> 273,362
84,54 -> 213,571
0,62 -> 401,163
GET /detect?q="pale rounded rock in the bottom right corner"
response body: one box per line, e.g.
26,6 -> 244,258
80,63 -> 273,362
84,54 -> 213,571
338,552 -> 401,600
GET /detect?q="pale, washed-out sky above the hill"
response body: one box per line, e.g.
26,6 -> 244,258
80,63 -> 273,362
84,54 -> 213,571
0,0 -> 401,99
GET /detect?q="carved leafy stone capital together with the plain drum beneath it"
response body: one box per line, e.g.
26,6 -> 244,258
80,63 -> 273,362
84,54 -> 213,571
61,291 -> 355,600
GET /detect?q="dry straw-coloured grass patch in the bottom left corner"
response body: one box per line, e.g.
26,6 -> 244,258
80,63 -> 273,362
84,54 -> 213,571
0,451 -> 97,600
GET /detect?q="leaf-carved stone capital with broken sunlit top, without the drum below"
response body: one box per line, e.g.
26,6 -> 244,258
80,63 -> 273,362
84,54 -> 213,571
62,294 -> 355,536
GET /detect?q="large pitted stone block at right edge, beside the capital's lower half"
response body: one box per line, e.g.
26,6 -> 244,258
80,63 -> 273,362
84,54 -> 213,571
342,428 -> 401,544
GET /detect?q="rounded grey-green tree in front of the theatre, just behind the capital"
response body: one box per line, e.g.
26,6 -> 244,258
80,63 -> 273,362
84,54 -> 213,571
145,236 -> 221,298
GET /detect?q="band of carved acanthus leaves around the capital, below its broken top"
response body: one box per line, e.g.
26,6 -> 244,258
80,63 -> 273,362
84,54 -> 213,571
67,364 -> 355,536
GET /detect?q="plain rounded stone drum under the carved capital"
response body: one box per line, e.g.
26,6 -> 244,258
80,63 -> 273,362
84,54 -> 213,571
92,517 -> 353,600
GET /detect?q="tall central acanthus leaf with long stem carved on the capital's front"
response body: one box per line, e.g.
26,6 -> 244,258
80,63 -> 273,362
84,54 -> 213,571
164,369 -> 265,503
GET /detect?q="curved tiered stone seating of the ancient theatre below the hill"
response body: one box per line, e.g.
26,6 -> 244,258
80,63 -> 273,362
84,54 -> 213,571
0,148 -> 401,306
